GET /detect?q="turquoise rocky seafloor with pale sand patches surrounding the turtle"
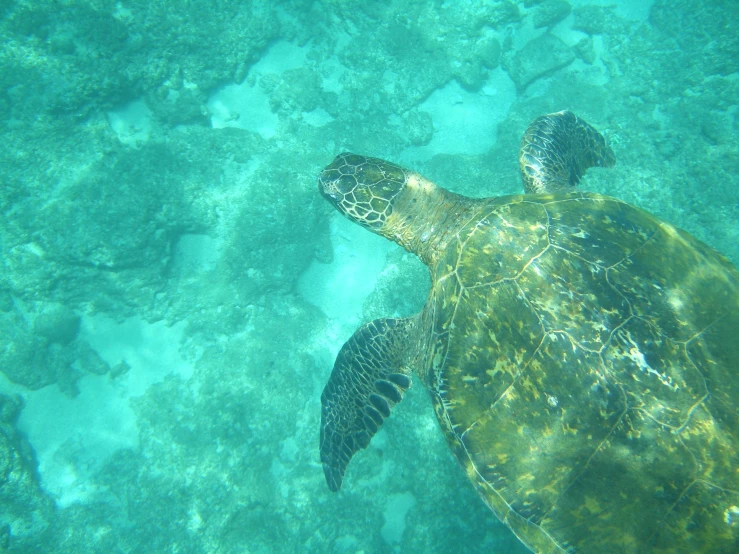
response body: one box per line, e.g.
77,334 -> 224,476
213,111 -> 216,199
0,0 -> 739,554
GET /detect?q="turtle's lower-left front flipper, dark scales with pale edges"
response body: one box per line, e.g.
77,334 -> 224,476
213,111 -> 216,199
321,318 -> 414,491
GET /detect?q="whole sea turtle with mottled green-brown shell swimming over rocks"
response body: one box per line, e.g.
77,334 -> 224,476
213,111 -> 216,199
318,112 -> 739,554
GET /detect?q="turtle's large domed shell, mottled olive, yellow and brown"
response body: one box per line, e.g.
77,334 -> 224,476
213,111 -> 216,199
422,193 -> 739,554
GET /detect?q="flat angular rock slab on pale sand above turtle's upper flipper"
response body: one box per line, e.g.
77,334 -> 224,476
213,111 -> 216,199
503,33 -> 575,92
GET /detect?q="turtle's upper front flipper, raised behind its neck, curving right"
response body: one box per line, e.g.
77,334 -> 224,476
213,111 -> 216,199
518,110 -> 616,193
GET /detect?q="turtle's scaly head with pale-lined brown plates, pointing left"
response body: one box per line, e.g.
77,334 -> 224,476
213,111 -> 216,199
318,152 -> 410,234
